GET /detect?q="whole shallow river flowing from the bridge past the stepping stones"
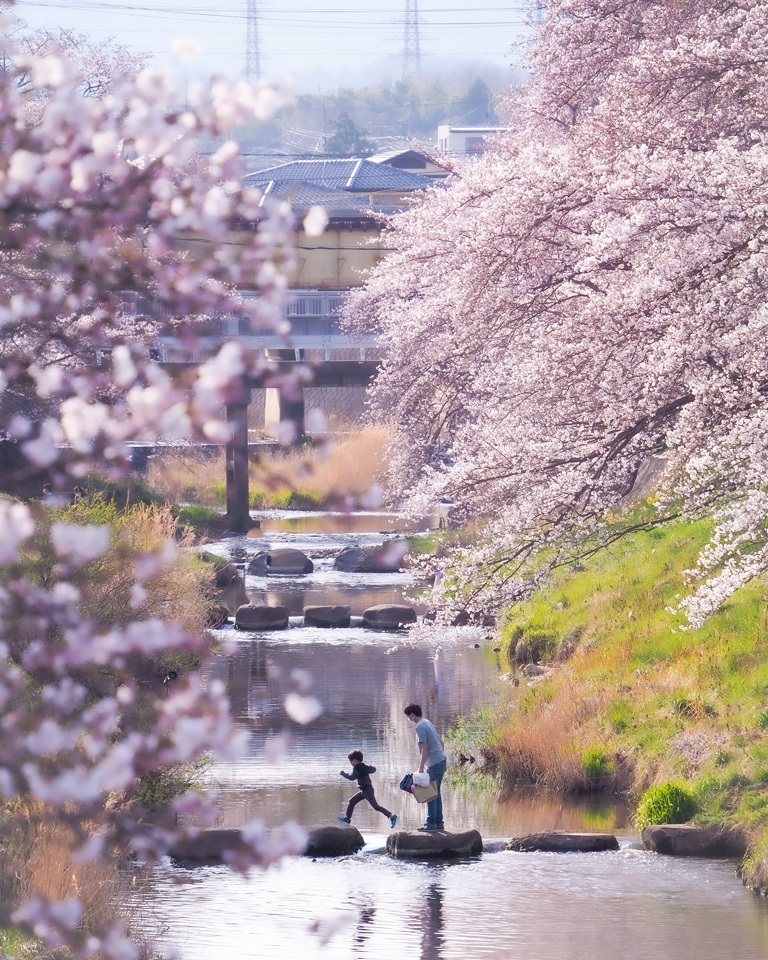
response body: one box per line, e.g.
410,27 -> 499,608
135,515 -> 768,960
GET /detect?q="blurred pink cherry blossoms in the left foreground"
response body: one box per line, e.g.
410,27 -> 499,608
0,15 -> 324,958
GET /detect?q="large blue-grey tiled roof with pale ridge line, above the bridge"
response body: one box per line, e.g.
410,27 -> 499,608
244,157 -> 428,193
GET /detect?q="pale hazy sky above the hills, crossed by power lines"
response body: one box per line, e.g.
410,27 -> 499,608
10,0 -> 527,89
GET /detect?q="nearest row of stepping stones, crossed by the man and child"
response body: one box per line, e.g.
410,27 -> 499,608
170,824 -> 747,865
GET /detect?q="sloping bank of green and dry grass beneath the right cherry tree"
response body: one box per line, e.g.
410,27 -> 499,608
457,521 -> 768,888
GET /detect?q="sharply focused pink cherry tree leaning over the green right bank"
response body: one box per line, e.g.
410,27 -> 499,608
347,0 -> 768,624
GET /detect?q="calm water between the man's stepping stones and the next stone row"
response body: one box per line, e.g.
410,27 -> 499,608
206,628 -> 502,831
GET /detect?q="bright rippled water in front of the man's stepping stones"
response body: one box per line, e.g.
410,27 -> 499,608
140,848 -> 768,960
